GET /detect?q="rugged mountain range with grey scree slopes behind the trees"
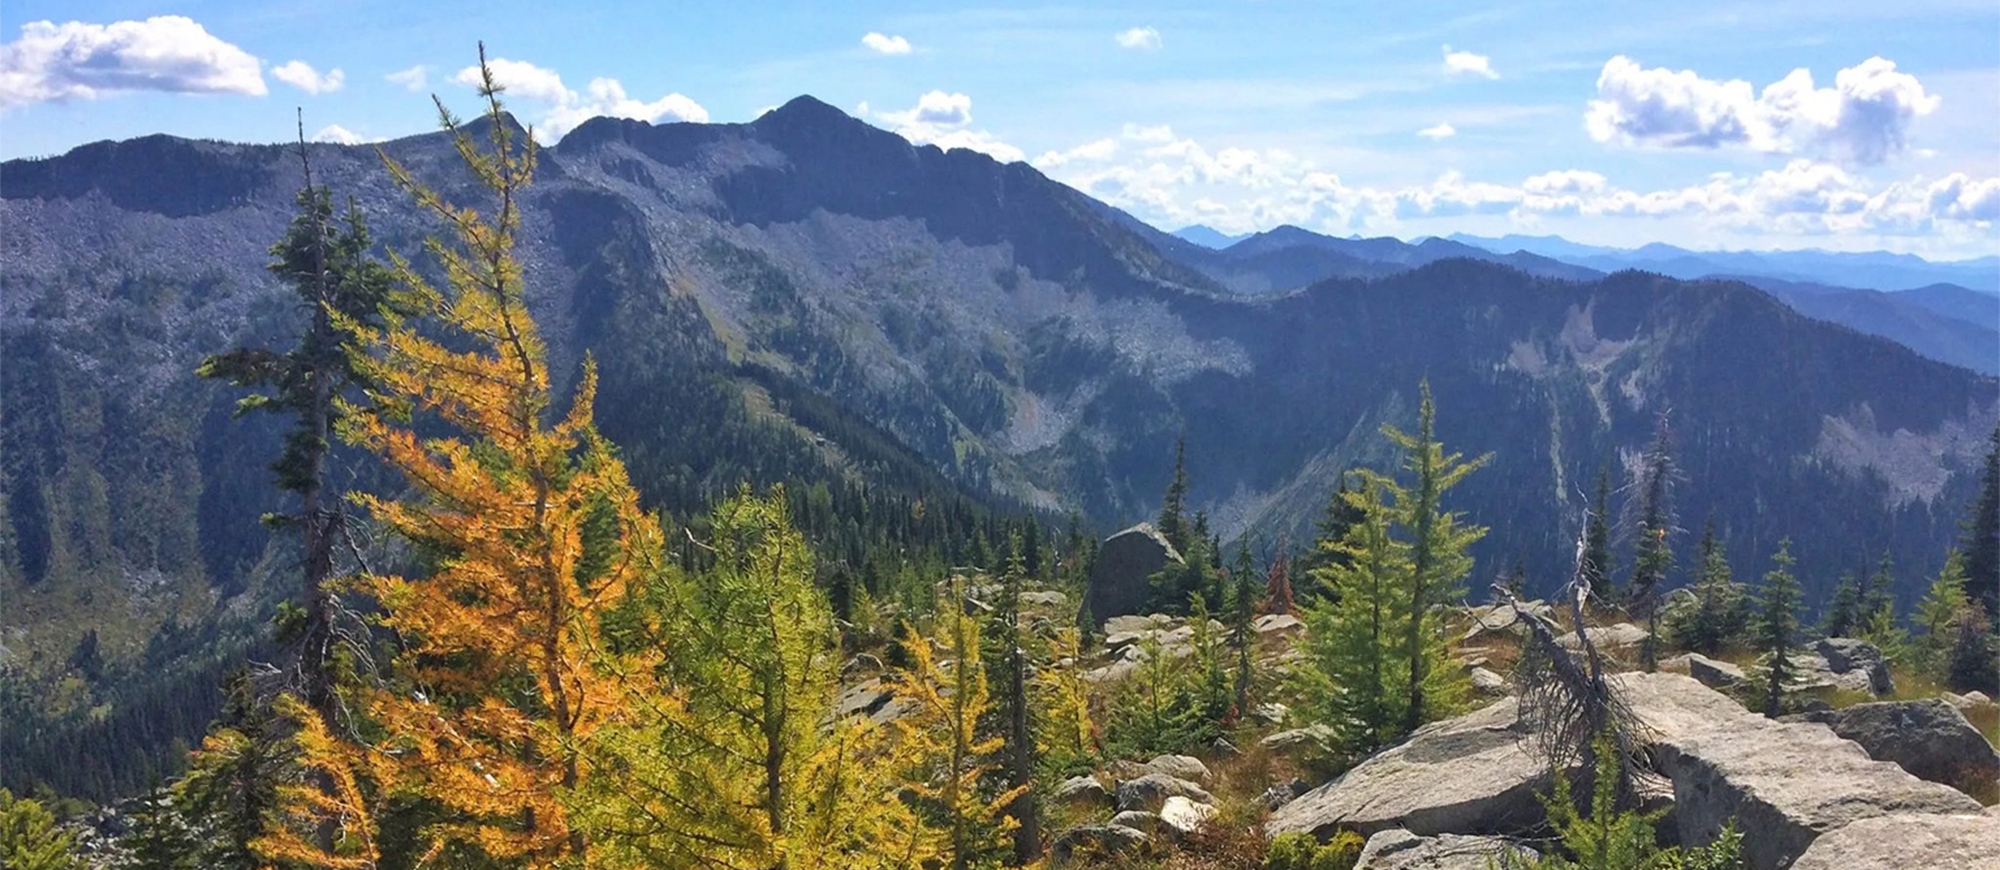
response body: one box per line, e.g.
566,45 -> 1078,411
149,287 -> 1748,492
0,98 -> 2000,680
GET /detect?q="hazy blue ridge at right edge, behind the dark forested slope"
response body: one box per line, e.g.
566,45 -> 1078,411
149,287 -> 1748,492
1718,276 -> 2000,374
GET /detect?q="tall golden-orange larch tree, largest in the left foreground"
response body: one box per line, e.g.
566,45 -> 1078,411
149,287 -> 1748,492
326,48 -> 664,866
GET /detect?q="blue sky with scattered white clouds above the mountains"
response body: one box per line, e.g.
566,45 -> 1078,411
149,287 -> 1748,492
11,0 -> 2000,258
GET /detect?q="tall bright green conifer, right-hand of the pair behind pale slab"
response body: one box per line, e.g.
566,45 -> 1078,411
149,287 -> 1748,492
1386,380 -> 1490,734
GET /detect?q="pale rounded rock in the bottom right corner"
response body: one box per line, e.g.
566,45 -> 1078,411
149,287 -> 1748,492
1792,812 -> 2000,870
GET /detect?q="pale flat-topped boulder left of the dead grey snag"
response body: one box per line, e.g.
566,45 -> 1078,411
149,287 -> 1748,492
1264,700 -> 1552,840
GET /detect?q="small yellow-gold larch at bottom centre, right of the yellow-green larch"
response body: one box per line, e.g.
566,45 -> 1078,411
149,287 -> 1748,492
896,578 -> 1026,870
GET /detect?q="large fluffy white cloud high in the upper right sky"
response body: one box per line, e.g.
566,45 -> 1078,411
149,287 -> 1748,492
1584,54 -> 1940,164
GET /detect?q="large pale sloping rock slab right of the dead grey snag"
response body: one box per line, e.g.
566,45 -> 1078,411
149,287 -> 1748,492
1612,674 -> 1980,870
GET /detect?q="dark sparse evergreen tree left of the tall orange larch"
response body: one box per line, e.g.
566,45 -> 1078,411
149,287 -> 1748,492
196,126 -> 404,748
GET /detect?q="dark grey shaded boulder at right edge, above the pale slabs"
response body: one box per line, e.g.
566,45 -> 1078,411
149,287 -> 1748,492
1808,698 -> 2000,786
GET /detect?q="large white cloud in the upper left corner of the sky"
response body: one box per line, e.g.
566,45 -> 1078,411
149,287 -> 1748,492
0,16 -> 266,108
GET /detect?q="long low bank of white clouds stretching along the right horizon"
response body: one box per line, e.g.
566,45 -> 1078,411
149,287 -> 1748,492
1034,124 -> 2000,238
